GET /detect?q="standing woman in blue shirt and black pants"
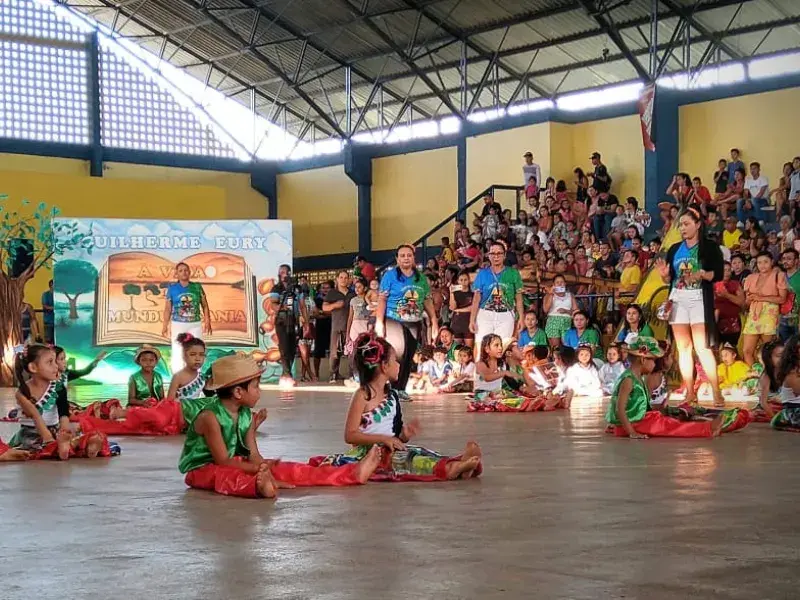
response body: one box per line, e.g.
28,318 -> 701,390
375,244 -> 439,395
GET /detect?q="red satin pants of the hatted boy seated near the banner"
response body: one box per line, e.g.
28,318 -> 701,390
70,398 -> 185,436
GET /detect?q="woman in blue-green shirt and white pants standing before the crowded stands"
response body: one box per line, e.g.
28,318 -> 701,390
470,242 -> 525,348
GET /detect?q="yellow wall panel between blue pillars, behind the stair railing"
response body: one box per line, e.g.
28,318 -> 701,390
374,147 -> 456,250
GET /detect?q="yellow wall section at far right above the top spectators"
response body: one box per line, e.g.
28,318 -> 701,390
678,88 -> 800,189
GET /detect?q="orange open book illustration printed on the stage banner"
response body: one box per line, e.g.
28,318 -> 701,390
95,252 -> 258,346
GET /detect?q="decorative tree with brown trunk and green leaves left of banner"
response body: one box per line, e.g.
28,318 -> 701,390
0,195 -> 92,386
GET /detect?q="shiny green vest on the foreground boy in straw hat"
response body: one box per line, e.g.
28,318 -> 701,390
178,396 -> 252,473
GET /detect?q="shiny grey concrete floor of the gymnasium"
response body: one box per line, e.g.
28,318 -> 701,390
0,391 -> 800,600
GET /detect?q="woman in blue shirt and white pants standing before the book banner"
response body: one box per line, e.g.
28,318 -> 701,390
161,262 -> 211,373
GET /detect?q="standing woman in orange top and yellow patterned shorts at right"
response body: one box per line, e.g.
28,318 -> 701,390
742,252 -> 788,366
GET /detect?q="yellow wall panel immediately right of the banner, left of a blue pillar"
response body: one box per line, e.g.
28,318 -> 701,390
278,165 -> 358,256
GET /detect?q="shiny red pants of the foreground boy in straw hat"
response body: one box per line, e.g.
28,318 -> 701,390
185,461 -> 361,498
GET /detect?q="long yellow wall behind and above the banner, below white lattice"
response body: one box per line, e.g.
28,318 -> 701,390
0,154 -> 268,308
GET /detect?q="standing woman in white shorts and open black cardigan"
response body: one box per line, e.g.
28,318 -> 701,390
656,204 -> 725,406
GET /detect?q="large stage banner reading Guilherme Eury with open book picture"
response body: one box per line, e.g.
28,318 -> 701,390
53,219 -> 292,383
